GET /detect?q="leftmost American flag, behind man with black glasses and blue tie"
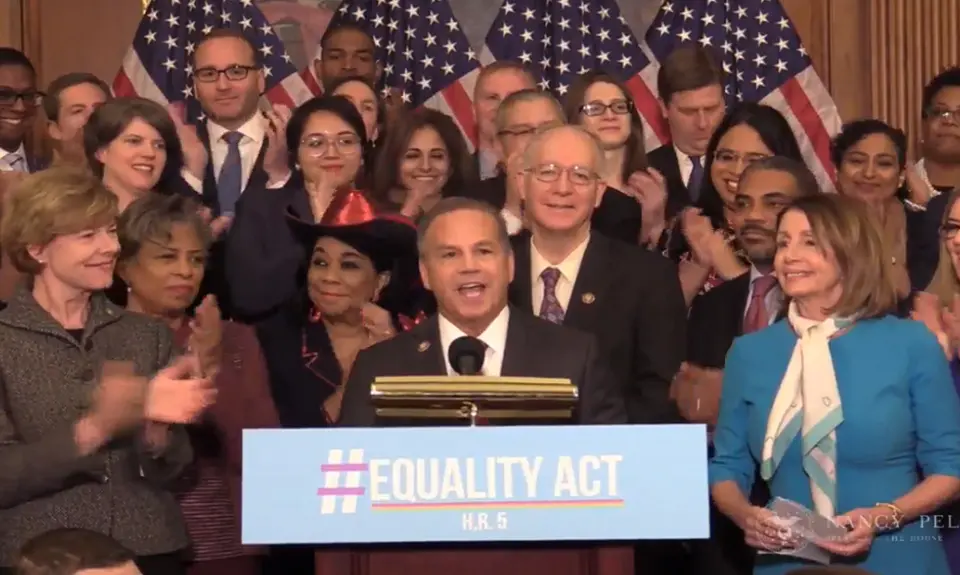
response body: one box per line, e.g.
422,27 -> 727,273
113,0 -> 313,122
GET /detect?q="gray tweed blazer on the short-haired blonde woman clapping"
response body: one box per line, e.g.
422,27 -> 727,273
0,288 -> 193,567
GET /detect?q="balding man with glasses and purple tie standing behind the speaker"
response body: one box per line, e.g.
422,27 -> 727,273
510,126 -> 687,423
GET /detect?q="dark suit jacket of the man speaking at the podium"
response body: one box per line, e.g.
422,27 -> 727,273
339,308 -> 627,427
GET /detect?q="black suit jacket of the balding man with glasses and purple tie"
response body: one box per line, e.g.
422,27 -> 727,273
510,233 -> 687,423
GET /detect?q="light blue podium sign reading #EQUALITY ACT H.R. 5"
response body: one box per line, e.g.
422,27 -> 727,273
242,425 -> 710,544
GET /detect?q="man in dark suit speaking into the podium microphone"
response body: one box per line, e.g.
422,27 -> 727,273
340,198 -> 627,427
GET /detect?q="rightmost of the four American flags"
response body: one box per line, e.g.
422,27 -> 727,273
638,0 -> 840,189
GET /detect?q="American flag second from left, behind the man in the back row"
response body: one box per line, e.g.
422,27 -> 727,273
330,0 -> 480,149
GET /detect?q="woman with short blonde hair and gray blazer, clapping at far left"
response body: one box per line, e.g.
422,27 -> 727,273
0,167 -> 213,575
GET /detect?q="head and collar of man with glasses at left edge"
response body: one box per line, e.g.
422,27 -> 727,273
0,47 -> 43,173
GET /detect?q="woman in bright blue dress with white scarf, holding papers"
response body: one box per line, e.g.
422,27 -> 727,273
710,195 -> 960,575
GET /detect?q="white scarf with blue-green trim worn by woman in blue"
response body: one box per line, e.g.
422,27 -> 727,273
760,302 -> 852,517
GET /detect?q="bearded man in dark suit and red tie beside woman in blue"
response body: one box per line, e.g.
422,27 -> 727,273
671,156 -> 820,575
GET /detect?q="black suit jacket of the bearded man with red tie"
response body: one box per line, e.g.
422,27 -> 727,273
687,272 -> 750,369
